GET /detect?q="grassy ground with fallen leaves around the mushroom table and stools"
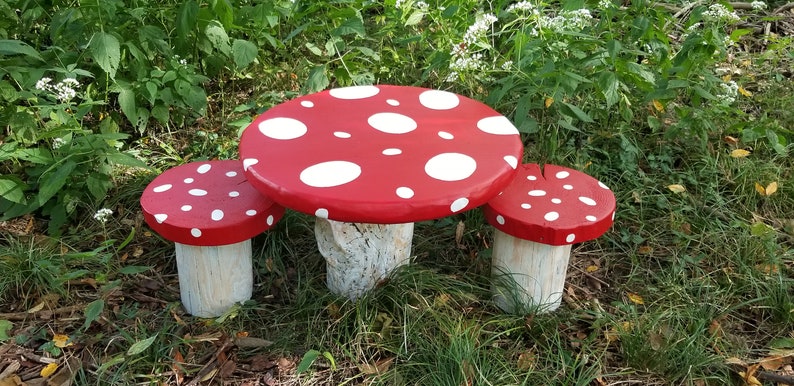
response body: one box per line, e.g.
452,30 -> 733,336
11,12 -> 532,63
0,3 -> 794,386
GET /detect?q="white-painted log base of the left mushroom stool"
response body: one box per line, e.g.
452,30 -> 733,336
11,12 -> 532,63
176,240 -> 254,318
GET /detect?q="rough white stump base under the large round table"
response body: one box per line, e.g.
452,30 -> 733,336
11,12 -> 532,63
314,217 -> 414,300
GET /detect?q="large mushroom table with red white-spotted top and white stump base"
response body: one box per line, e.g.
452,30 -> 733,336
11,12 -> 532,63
239,85 -> 523,300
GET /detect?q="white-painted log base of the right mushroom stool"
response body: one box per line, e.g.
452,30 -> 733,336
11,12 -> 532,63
491,229 -> 571,314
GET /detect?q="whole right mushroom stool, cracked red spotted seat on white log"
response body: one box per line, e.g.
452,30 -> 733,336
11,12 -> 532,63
483,164 -> 615,313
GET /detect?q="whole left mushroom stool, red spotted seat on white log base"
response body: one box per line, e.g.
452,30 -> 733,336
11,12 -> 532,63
141,160 -> 284,317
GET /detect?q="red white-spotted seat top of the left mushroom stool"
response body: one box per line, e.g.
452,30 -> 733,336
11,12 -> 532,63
141,160 -> 284,246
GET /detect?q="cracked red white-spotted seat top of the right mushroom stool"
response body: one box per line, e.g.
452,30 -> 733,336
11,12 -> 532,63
483,164 -> 615,245
